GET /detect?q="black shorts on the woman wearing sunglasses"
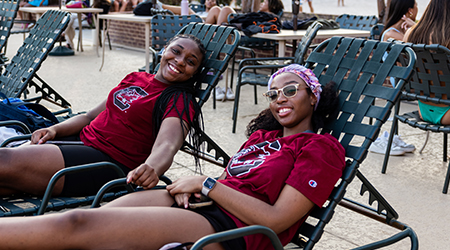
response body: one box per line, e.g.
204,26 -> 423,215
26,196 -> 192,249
172,203 -> 247,250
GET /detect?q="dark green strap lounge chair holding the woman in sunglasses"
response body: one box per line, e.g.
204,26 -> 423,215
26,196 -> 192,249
191,37 -> 418,250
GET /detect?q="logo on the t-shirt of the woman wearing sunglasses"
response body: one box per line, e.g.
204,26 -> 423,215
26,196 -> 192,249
227,140 -> 281,176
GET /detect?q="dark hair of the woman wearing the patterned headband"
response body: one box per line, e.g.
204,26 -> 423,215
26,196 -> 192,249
245,82 -> 339,137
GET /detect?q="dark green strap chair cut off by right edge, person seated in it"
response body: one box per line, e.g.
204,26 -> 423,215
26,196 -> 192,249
381,43 -> 450,194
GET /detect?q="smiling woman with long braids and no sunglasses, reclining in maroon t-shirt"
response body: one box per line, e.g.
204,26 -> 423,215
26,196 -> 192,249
0,35 -> 206,196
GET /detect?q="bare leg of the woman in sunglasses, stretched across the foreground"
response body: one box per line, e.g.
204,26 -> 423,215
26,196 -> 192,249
0,207 -> 222,250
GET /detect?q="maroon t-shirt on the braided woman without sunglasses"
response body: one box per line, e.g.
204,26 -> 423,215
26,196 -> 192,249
80,72 -> 194,169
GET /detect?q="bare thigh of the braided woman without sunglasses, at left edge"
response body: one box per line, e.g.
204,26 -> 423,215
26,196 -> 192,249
0,144 -> 64,195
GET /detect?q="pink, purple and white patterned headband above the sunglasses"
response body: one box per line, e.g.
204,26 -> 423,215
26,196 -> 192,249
268,64 -> 322,110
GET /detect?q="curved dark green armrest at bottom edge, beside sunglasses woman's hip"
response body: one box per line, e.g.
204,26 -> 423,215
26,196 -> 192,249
191,225 -> 283,250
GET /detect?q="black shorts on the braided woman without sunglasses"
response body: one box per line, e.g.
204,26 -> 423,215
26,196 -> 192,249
57,137 -> 131,196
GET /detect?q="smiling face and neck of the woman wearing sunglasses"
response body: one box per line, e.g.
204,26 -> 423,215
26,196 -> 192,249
270,73 -> 317,136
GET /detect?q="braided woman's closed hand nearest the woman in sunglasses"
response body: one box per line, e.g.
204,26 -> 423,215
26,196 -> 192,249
127,163 -> 159,189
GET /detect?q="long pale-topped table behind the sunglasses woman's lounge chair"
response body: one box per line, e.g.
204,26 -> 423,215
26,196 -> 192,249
252,29 -> 370,57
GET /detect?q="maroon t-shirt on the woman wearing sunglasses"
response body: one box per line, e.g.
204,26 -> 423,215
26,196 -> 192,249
220,130 -> 345,250
